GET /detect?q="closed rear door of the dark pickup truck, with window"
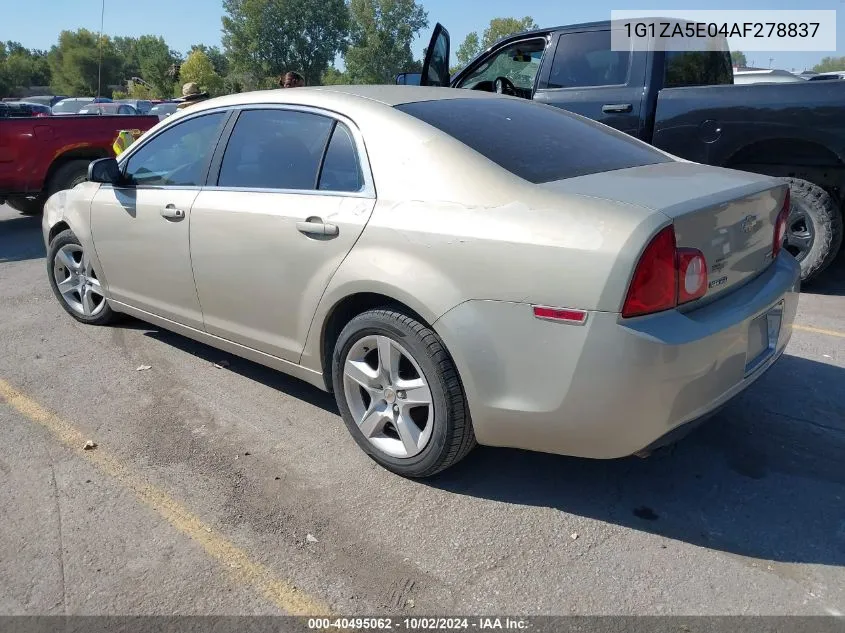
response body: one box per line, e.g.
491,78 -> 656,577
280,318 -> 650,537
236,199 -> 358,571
534,27 -> 647,136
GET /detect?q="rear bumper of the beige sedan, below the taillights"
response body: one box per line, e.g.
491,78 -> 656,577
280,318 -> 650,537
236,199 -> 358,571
434,254 -> 800,458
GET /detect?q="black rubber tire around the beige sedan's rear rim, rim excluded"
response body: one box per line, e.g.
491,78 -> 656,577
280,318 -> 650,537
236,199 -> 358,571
332,308 -> 476,478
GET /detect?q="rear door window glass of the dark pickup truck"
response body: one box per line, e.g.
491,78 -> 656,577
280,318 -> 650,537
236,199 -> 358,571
548,30 -> 631,88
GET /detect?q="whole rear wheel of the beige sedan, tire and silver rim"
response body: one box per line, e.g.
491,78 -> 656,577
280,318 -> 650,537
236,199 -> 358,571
332,309 -> 475,477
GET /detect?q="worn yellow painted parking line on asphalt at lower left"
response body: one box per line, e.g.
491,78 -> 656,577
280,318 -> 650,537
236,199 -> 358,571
0,378 -> 329,615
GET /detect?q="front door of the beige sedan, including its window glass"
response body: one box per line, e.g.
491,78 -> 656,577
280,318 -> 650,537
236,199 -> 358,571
91,112 -> 225,328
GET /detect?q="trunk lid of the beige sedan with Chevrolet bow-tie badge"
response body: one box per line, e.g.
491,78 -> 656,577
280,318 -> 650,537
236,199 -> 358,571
540,161 -> 787,299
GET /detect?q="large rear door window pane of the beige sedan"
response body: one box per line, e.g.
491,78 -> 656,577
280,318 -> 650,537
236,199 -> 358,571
217,109 -> 334,190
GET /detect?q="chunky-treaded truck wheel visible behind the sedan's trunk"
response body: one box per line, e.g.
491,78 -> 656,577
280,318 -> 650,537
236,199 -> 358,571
783,178 -> 842,281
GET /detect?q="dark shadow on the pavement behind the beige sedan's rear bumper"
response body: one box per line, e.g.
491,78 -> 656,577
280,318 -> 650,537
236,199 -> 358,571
422,356 -> 845,566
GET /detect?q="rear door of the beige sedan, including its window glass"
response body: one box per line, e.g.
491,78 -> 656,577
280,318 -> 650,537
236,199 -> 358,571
191,106 -> 375,362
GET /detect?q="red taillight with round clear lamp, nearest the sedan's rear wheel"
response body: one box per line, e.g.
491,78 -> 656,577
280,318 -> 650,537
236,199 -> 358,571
622,225 -> 707,317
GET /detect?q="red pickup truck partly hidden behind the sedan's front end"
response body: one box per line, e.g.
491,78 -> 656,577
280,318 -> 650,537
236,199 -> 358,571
0,115 -> 158,214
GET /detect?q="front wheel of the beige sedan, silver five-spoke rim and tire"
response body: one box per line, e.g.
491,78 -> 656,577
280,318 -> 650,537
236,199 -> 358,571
47,230 -> 114,325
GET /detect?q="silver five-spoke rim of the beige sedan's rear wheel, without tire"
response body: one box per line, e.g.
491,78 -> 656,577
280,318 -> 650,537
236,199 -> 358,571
343,335 -> 434,458
